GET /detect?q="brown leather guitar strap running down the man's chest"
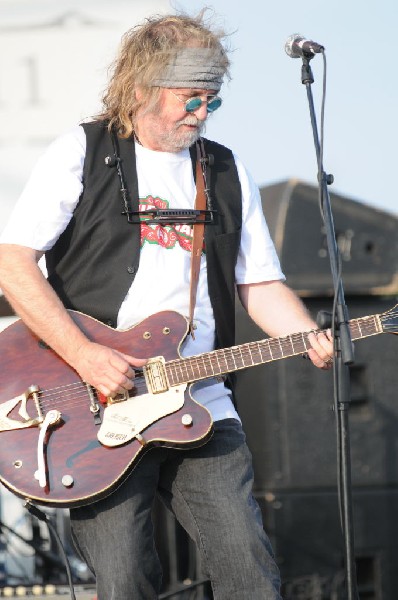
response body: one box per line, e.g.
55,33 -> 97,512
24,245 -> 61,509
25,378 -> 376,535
189,143 -> 206,339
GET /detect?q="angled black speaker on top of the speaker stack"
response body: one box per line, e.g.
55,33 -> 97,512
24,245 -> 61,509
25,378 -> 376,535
260,180 -> 398,296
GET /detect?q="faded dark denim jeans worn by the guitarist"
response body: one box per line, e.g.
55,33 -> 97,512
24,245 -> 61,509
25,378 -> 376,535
71,419 -> 281,600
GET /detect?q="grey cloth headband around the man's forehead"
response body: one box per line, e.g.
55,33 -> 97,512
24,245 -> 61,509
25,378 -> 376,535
152,48 -> 227,92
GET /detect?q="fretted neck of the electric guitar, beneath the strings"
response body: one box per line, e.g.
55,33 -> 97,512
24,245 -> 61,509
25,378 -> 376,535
166,315 -> 383,386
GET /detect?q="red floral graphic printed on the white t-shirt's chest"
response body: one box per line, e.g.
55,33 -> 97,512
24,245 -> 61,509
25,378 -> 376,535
139,196 -> 202,252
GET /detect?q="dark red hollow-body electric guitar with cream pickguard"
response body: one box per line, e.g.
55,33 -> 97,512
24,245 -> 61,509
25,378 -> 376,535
0,305 -> 398,507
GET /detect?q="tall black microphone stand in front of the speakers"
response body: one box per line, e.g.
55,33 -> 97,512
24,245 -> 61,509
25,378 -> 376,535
301,52 -> 358,600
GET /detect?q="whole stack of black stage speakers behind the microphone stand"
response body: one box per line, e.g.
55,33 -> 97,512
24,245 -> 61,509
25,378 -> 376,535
236,181 -> 398,600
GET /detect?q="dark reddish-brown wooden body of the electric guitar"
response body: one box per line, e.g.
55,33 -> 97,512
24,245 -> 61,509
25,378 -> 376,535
0,311 -> 212,507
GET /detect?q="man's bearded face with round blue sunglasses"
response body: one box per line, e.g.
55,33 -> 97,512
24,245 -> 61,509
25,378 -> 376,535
136,88 -> 215,152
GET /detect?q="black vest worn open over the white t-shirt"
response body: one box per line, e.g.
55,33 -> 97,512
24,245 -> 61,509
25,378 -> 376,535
46,122 -> 242,347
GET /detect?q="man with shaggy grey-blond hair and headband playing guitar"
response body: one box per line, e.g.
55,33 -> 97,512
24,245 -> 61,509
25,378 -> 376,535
0,12 -> 333,600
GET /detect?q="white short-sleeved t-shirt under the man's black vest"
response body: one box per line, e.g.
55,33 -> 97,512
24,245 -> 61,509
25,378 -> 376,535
0,126 -> 284,420
